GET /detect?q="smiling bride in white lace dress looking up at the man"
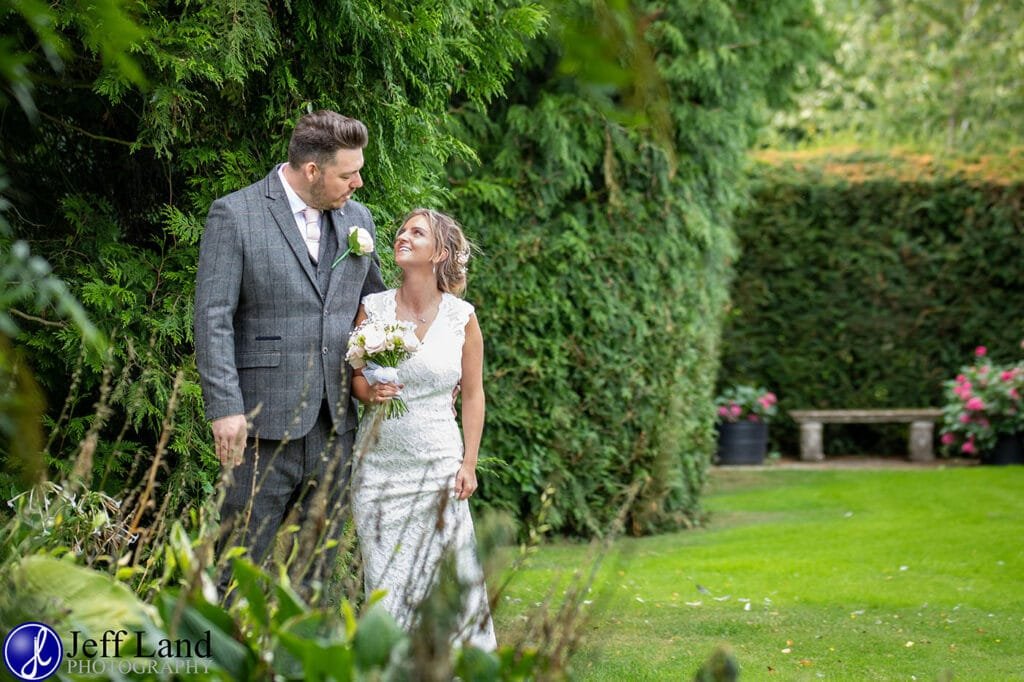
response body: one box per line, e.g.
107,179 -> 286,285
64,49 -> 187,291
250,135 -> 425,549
352,209 -> 497,650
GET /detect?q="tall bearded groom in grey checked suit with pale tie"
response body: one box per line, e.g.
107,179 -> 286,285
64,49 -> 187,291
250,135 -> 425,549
195,111 -> 384,589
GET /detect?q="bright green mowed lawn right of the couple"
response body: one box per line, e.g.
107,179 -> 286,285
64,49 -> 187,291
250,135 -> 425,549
496,467 -> 1024,681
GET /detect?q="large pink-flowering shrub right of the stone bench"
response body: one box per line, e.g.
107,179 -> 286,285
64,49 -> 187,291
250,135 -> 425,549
939,342 -> 1024,455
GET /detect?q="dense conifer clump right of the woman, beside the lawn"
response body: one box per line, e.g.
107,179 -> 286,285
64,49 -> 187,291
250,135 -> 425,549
452,0 -> 820,535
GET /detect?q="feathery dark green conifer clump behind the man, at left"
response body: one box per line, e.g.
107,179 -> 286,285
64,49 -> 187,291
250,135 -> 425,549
0,0 -> 546,505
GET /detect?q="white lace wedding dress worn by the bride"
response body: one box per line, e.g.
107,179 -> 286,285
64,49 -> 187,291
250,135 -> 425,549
352,289 -> 497,650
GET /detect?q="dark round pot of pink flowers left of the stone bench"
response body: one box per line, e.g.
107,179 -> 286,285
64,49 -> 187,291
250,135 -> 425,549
715,385 -> 778,464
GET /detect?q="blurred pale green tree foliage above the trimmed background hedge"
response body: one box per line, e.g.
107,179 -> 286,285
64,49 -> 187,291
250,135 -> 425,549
771,0 -> 1024,153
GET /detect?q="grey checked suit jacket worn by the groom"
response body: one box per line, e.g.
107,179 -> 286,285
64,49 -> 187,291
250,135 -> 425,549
195,168 -> 384,440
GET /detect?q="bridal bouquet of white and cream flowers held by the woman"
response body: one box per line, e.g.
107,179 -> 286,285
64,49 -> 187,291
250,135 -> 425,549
345,317 -> 420,419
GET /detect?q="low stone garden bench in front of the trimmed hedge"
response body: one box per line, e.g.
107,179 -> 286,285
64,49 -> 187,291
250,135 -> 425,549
788,408 -> 942,462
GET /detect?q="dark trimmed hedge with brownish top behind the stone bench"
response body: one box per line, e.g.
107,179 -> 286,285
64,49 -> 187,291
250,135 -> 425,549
720,151 -> 1024,454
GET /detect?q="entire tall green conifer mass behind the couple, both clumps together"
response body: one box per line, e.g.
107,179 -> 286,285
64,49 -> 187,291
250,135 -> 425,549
2,0 -> 820,535
